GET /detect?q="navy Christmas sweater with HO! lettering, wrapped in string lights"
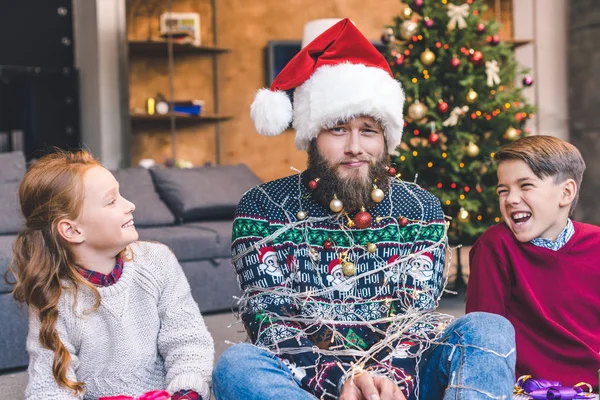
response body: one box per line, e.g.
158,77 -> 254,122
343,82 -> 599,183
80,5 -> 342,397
232,172 -> 446,398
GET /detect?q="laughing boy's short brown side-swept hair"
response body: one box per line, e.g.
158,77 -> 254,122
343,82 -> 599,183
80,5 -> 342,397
494,135 -> 585,214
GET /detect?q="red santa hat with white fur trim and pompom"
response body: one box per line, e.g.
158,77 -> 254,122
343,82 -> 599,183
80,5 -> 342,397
250,18 -> 404,153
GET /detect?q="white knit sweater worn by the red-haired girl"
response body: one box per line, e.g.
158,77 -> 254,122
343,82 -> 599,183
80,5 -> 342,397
25,242 -> 214,400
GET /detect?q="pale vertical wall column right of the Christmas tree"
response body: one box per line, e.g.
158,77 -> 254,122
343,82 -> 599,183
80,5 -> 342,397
513,0 -> 569,140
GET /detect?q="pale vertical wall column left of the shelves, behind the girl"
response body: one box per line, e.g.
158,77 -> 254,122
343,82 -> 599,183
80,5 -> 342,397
73,0 -> 129,169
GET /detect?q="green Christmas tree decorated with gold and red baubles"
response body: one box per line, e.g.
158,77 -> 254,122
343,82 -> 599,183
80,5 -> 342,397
382,0 -> 533,244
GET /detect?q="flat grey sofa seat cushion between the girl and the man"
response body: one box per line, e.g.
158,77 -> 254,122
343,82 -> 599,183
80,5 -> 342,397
137,225 -> 225,262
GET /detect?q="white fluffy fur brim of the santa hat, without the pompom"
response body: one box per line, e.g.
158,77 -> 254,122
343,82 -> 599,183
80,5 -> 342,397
292,62 -> 404,154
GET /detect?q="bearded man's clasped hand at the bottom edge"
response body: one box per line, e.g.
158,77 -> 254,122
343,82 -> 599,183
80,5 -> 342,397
339,372 -> 406,400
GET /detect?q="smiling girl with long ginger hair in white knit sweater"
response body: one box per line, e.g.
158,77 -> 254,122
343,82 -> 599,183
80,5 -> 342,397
12,151 -> 214,400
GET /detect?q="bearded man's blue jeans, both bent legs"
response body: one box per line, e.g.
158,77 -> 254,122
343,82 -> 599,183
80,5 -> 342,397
213,313 -> 516,400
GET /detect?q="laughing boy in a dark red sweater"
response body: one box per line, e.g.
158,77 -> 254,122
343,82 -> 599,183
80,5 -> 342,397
467,136 -> 600,389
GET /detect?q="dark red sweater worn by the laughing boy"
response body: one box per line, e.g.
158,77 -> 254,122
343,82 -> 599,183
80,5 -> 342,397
467,222 -> 600,390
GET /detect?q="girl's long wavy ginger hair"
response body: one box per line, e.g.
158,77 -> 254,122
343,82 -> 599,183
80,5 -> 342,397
7,150 -> 100,394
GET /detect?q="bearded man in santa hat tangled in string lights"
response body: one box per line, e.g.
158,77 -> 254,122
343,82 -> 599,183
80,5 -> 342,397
213,19 -> 515,400
